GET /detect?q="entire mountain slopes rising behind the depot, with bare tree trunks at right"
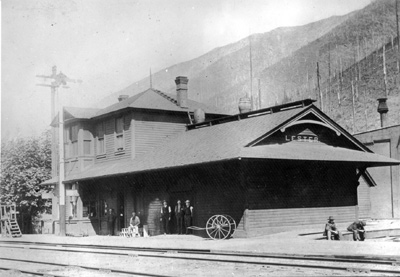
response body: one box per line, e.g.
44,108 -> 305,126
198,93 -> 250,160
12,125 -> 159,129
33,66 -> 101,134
98,0 -> 400,132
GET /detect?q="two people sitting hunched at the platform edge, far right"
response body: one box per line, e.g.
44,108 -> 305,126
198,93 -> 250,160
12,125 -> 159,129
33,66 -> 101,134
324,216 -> 367,241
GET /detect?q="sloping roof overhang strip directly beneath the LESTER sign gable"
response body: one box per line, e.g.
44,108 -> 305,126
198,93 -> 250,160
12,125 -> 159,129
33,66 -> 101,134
241,143 -> 400,168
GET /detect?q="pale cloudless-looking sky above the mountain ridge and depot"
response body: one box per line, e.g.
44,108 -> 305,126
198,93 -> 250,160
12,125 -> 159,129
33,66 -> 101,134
1,0 -> 371,140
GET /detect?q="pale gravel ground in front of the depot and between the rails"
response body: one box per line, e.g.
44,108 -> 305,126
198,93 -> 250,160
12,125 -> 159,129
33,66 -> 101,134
0,220 -> 400,276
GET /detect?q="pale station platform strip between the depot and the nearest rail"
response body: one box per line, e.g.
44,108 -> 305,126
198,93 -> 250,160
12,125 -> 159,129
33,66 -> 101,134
0,220 -> 400,260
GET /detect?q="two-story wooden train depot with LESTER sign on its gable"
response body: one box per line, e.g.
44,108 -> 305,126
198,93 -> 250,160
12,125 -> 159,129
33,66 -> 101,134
42,77 -> 400,237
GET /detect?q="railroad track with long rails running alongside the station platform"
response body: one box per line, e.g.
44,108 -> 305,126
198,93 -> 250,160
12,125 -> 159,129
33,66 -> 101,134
0,241 -> 400,276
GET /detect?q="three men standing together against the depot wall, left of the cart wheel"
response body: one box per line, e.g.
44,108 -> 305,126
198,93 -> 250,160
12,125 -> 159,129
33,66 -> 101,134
160,200 -> 193,234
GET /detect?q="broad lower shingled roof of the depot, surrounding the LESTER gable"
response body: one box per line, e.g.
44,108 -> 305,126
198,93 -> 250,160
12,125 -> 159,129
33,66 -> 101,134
42,100 -> 400,182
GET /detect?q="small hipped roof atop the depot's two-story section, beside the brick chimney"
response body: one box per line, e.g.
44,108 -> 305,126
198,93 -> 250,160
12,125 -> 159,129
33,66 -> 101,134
95,88 -> 226,117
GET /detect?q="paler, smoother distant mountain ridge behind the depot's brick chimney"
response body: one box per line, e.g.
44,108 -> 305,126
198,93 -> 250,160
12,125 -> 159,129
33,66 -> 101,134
99,12 -> 349,109
